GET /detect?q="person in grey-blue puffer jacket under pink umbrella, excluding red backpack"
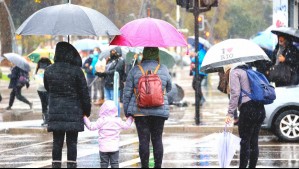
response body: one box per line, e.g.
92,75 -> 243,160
124,47 -> 172,168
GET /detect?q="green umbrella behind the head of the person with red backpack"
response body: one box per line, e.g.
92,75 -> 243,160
126,48 -> 176,69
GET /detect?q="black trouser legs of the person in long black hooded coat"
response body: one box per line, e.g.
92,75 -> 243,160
52,131 -> 78,162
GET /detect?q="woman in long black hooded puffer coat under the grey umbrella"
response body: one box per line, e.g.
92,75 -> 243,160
44,42 -> 91,168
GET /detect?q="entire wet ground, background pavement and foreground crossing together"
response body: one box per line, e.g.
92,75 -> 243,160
0,68 -> 299,168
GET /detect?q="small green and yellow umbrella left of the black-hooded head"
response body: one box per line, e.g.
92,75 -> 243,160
27,49 -> 55,63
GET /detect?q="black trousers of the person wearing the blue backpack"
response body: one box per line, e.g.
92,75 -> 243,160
239,101 -> 266,168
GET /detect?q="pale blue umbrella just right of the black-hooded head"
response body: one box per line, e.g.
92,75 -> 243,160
73,39 -> 101,51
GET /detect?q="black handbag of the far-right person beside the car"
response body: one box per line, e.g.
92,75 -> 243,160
269,63 -> 292,83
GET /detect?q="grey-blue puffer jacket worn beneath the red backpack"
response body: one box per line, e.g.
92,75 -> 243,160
124,61 -> 172,119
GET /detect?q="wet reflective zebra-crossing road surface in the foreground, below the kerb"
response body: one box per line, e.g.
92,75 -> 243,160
0,132 -> 299,168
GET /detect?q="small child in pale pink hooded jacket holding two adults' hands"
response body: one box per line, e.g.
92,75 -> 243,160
84,101 -> 134,168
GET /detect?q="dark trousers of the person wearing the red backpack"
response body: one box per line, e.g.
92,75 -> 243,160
135,116 -> 165,168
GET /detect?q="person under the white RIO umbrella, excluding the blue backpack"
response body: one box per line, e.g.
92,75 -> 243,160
226,63 -> 266,168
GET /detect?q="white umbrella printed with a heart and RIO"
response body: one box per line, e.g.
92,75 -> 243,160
201,39 -> 271,73
